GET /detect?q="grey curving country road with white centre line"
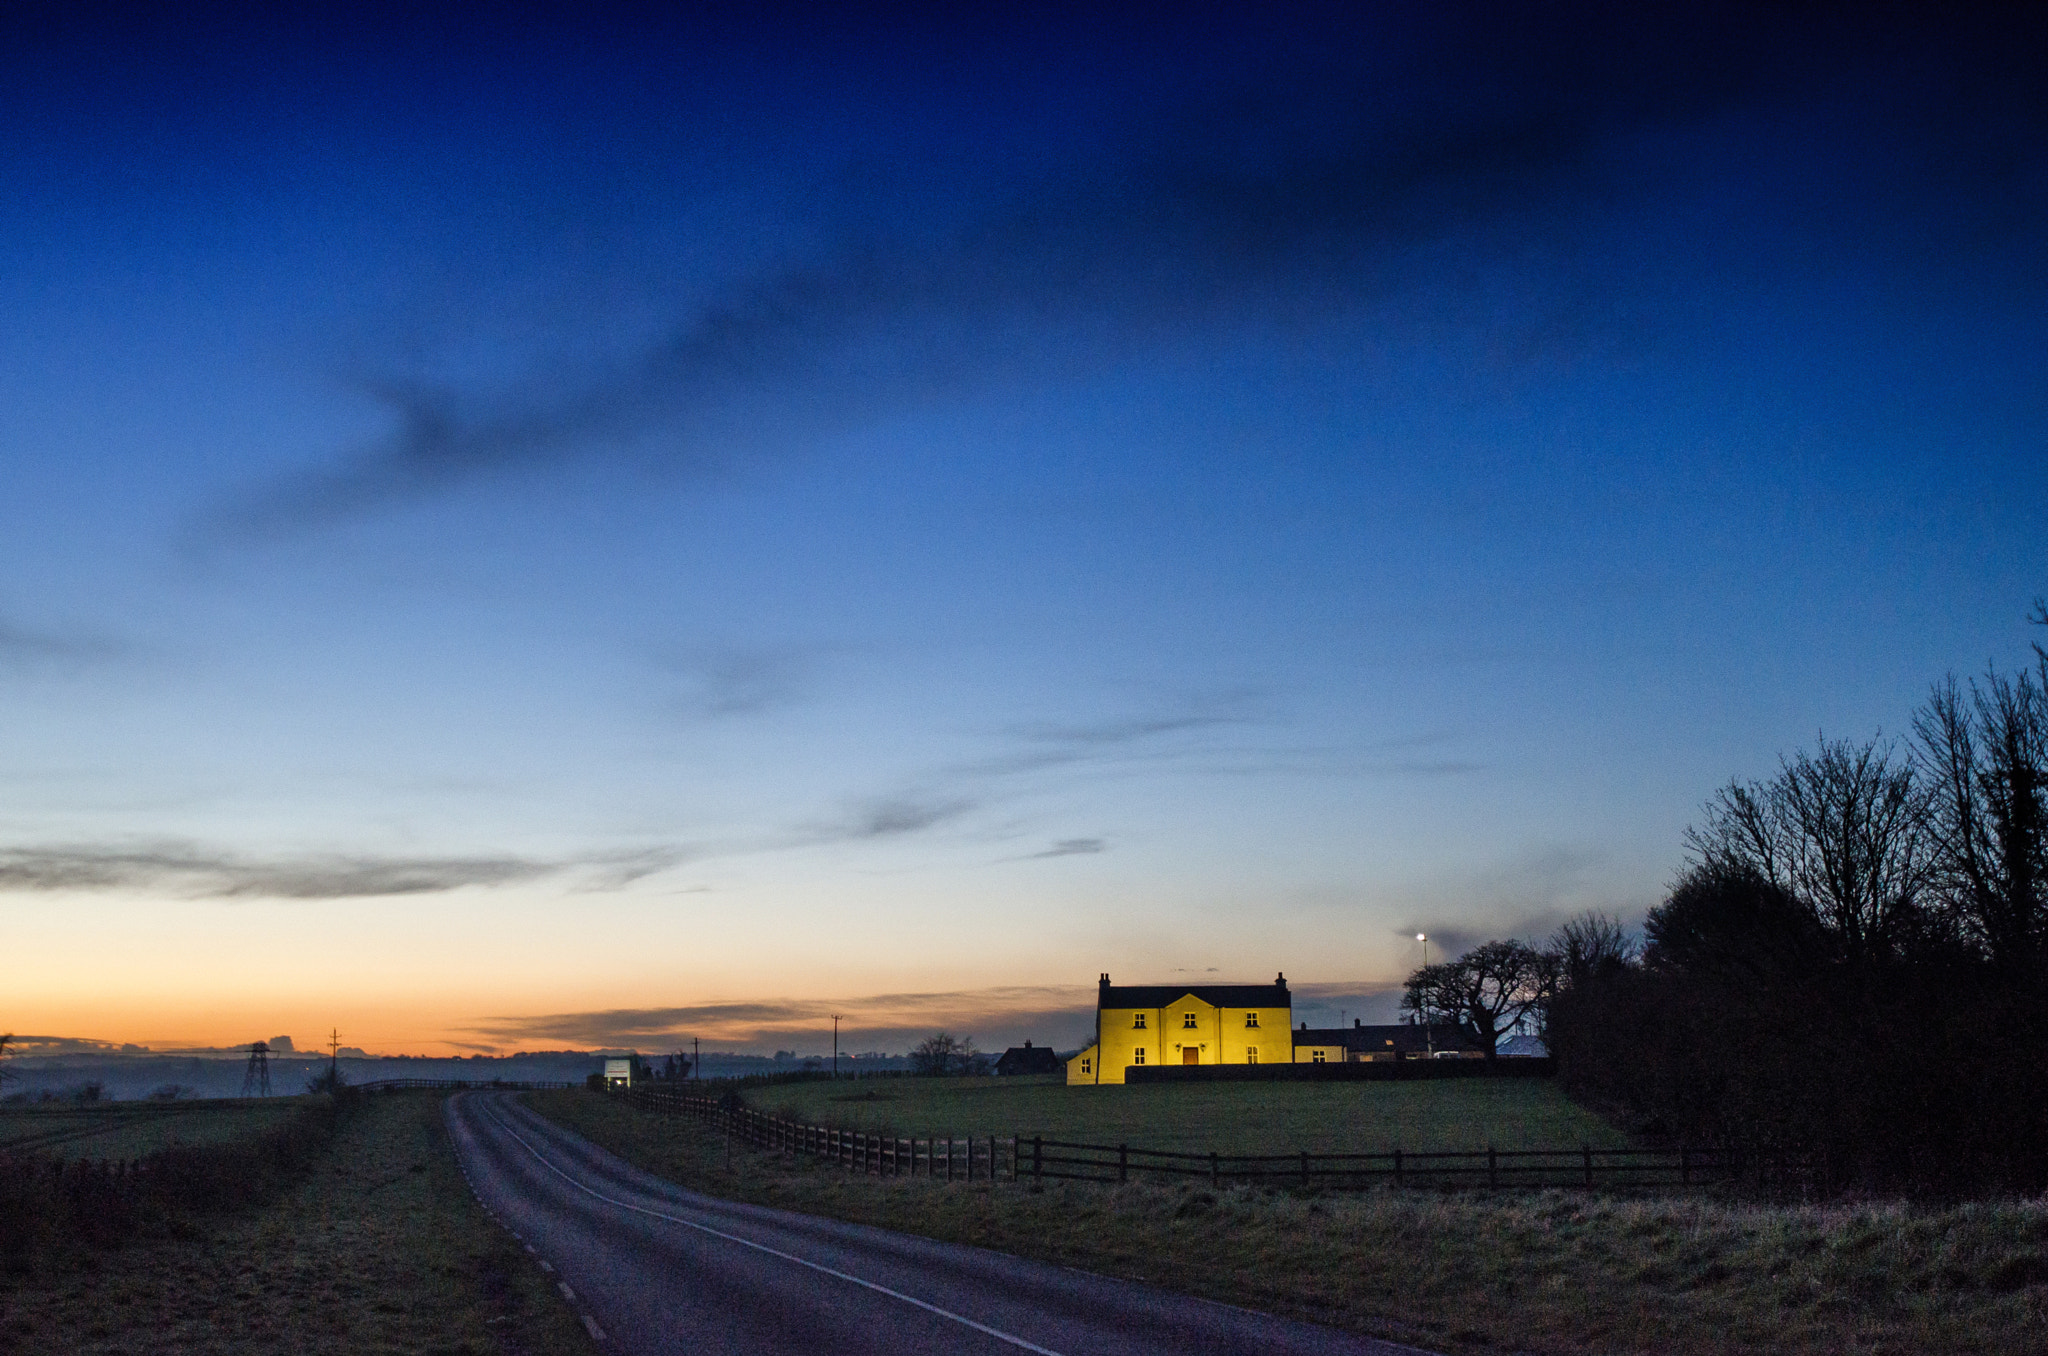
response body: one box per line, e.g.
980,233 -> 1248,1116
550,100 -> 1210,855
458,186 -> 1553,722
446,1092 -> 1427,1356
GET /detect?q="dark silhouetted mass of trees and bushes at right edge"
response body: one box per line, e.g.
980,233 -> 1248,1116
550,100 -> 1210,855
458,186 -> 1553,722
1542,604 -> 2048,1194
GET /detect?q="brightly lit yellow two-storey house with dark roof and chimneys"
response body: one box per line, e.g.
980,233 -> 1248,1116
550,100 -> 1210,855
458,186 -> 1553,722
1067,975 -> 1294,1086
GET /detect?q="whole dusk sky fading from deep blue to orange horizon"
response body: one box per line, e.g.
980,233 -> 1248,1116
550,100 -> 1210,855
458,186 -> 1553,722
0,2 -> 2048,1053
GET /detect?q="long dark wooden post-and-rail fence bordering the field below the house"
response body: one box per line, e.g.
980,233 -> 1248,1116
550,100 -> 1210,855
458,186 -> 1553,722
612,1088 -> 1731,1188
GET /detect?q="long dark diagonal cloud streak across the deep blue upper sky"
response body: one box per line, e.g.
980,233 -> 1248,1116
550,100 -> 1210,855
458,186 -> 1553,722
199,6 -> 1908,537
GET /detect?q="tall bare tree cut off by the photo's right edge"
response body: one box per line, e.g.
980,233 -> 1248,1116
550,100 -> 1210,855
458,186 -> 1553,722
1913,671 -> 2048,975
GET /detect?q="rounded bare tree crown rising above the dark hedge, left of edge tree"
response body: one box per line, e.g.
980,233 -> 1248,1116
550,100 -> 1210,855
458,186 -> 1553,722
1686,737 -> 1937,963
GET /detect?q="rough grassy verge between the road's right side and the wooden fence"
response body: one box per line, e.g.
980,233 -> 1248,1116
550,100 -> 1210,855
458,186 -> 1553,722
530,1092 -> 2048,1356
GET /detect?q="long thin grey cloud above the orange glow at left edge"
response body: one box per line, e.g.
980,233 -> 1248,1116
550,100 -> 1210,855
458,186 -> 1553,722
0,844 -> 561,899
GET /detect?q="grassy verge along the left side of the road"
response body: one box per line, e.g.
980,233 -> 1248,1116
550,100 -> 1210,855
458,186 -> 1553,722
0,1094 -> 596,1356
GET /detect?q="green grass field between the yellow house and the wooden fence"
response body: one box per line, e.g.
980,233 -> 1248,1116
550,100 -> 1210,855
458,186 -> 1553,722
745,1075 -> 1628,1153
